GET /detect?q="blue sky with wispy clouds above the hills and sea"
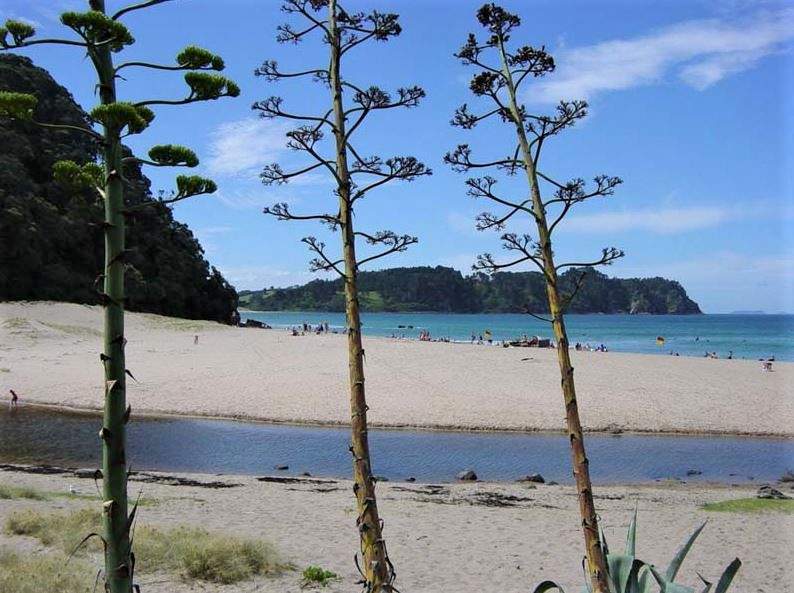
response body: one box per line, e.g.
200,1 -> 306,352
0,0 -> 794,312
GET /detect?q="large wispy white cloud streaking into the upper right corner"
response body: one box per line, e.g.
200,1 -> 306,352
531,8 -> 794,103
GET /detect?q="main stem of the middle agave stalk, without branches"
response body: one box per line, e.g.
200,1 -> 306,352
328,0 -> 393,593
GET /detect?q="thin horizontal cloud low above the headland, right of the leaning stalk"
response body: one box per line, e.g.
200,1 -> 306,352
560,206 -> 731,235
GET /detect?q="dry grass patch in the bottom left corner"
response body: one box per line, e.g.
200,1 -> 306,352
0,548 -> 95,593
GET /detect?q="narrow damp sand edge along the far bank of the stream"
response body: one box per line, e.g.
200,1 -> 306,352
20,398 -> 794,441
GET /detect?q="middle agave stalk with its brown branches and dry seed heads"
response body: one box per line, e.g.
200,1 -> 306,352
253,0 -> 431,593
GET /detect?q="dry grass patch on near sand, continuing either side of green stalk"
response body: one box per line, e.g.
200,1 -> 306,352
5,509 -> 291,584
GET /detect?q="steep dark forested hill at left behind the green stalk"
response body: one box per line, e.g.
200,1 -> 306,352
0,54 -> 237,322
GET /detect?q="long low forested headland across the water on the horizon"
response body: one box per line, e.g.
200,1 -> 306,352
240,266 -> 701,315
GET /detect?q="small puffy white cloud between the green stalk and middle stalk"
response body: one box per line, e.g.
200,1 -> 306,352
207,118 -> 290,176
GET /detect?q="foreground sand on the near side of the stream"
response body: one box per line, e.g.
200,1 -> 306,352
0,472 -> 794,593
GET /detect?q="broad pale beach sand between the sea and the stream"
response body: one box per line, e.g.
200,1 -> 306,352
0,303 -> 794,436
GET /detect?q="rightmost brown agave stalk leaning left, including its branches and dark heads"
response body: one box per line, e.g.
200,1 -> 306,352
444,4 -> 623,593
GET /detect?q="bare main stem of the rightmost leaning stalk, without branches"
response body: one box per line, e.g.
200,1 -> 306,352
499,37 -> 609,593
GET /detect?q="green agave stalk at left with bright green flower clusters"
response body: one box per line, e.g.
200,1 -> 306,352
0,0 -> 240,593
